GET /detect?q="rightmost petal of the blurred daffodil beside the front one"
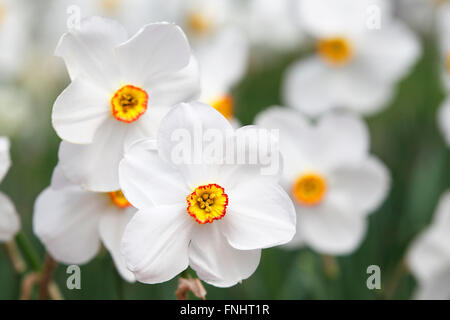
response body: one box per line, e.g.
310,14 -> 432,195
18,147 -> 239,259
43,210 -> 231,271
329,157 -> 390,214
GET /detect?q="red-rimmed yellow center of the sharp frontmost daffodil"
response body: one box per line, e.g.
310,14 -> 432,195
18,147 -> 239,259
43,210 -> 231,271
186,184 -> 228,224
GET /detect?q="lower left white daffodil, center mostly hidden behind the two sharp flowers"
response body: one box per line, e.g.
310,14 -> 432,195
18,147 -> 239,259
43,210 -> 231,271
33,167 -> 136,282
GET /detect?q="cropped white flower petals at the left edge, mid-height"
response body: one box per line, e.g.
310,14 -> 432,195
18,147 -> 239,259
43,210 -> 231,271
0,137 -> 20,242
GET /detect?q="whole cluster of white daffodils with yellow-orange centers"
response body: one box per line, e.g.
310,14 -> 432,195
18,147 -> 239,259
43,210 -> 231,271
0,0 -> 450,298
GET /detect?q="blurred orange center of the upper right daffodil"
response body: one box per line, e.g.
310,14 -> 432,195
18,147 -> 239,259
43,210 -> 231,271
317,37 -> 354,66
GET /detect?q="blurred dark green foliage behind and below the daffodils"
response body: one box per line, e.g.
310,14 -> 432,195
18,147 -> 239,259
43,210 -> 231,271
0,33 -> 450,299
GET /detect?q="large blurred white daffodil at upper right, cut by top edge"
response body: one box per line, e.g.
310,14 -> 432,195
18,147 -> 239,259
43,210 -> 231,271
283,0 -> 421,116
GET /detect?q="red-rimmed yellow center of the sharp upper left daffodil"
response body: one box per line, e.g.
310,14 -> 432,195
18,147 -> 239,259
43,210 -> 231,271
111,85 -> 148,123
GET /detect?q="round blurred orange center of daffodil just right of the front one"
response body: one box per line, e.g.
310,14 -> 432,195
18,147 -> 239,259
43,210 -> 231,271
292,173 -> 327,206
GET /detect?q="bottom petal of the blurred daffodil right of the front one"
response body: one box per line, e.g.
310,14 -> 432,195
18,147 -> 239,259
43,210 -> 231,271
297,197 -> 367,255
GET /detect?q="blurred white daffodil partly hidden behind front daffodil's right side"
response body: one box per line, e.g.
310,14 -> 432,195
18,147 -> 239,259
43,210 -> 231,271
256,107 -> 390,255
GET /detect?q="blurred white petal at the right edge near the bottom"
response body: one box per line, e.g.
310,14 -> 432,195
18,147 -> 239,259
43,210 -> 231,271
407,227 -> 450,283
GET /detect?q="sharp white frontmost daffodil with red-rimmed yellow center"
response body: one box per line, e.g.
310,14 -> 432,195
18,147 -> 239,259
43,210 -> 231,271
119,102 -> 295,287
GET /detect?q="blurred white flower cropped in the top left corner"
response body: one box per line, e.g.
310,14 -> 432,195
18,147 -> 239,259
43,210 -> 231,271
0,0 -> 30,80
